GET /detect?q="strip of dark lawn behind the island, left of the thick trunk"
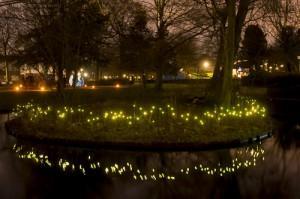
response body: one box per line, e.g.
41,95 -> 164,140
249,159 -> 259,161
0,84 -> 204,110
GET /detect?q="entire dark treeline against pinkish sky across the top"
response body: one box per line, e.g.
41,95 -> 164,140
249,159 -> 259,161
0,0 -> 300,105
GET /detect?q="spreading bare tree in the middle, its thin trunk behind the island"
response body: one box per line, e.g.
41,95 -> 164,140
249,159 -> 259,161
108,0 -> 206,90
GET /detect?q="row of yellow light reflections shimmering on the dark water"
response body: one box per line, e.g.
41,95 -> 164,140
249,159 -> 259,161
13,145 -> 264,181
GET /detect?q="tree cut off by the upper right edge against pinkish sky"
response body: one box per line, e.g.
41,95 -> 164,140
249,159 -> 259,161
264,0 -> 300,72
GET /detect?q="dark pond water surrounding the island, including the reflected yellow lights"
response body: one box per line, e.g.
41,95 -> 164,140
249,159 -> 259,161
0,115 -> 300,199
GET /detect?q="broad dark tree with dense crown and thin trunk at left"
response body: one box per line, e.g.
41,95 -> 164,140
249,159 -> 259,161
18,0 -> 106,91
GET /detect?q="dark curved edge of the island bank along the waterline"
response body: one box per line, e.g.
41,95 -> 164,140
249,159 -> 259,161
5,119 -> 272,151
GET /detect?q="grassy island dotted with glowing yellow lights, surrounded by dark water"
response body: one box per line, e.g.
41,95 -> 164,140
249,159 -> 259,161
6,99 -> 270,149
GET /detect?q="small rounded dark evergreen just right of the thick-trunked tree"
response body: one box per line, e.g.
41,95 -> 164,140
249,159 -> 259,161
241,25 -> 268,71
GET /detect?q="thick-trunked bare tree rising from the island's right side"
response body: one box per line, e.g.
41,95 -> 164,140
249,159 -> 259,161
198,0 -> 259,106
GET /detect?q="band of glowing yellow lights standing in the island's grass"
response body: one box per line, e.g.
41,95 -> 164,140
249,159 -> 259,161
14,100 -> 266,131
